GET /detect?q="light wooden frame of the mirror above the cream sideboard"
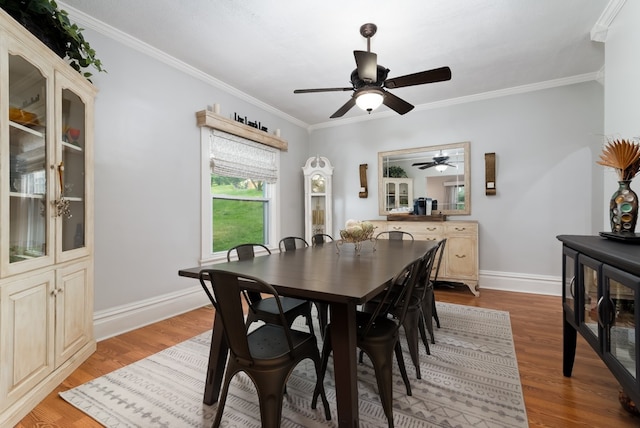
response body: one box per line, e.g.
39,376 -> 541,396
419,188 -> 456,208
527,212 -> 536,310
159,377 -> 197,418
378,141 -> 471,216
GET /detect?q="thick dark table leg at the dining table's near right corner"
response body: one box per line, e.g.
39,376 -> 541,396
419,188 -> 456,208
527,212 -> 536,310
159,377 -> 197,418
331,303 -> 359,428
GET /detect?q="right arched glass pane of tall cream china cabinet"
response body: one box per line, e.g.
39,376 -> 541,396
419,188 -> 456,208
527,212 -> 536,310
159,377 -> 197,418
56,89 -> 86,252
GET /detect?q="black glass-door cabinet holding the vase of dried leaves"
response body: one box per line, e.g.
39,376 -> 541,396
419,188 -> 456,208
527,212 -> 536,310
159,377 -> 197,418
558,235 -> 640,410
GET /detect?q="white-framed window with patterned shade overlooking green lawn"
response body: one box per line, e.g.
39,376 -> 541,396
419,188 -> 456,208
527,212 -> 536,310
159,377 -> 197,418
201,128 -> 280,261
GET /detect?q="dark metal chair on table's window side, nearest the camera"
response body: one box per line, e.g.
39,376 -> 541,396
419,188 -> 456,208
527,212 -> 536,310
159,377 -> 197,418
227,243 -> 313,333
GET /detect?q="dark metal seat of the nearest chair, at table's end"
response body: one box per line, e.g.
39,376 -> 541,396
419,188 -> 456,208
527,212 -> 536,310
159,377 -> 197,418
247,324 -> 317,365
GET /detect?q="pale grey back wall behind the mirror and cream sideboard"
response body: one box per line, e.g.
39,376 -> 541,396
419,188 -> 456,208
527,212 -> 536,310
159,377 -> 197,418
310,82 -> 603,282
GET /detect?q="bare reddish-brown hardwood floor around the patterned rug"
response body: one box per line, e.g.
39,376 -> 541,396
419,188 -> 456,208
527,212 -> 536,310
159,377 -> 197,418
17,287 -> 640,428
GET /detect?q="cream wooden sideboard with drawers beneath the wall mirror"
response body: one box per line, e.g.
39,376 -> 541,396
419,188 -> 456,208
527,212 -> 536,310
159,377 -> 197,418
371,220 -> 480,296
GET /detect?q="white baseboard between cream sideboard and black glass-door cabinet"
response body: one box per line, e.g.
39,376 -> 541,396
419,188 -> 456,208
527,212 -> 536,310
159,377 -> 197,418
479,271 -> 562,296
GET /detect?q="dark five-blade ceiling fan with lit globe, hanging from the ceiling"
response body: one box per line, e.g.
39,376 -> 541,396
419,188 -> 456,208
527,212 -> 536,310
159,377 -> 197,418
293,23 -> 451,119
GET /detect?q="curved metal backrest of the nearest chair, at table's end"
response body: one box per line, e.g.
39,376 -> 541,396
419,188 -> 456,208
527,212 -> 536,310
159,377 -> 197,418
199,269 -> 293,364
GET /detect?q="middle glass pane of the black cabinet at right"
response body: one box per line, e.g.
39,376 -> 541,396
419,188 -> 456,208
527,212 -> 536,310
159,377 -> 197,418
578,254 -> 603,350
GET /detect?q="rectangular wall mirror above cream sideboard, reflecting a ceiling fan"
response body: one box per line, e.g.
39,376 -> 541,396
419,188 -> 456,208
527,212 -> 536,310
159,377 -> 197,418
378,141 -> 471,216
